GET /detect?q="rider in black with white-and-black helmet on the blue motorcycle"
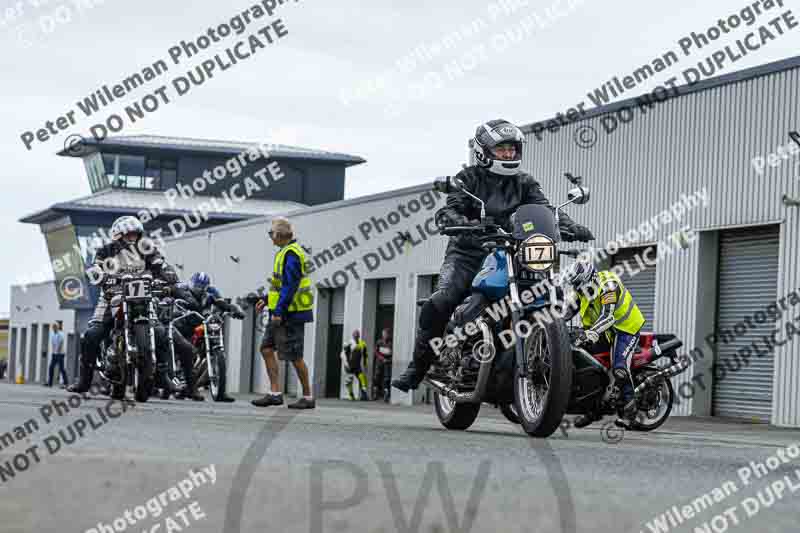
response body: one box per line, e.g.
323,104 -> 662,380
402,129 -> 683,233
392,119 -> 594,392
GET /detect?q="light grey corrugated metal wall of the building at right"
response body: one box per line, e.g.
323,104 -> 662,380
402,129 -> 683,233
525,62 -> 800,426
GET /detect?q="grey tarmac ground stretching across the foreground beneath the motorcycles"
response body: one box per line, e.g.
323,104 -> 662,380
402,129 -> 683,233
0,384 -> 800,533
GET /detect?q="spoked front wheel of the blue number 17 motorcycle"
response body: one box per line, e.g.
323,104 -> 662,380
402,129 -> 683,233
514,320 -> 573,437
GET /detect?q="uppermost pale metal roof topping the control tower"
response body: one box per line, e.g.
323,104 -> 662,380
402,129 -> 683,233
58,135 -> 366,166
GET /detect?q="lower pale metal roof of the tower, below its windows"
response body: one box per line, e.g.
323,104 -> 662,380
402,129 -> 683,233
20,189 -> 307,224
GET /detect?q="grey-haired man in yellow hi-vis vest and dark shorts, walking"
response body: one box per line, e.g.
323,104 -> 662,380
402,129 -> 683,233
251,218 -> 315,409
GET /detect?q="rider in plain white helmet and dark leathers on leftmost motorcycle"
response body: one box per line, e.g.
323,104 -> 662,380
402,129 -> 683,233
67,216 -> 199,400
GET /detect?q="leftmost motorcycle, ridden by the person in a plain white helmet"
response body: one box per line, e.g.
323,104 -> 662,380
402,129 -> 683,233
97,274 -> 167,403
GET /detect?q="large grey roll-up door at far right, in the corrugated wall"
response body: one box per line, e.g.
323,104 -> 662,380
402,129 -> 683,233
713,226 -> 779,421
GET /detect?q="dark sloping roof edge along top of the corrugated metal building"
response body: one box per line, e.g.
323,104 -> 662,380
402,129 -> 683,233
520,56 -> 800,133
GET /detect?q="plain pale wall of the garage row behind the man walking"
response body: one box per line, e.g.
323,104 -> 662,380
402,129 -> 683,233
166,183 -> 446,402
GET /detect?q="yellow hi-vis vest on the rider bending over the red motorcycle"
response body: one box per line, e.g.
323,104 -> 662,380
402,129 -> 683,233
578,270 -> 644,341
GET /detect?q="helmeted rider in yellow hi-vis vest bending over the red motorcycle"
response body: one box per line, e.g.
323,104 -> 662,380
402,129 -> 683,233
564,258 -> 644,427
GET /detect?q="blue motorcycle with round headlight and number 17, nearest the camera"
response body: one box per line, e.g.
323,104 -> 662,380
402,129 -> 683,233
425,176 -> 589,437
